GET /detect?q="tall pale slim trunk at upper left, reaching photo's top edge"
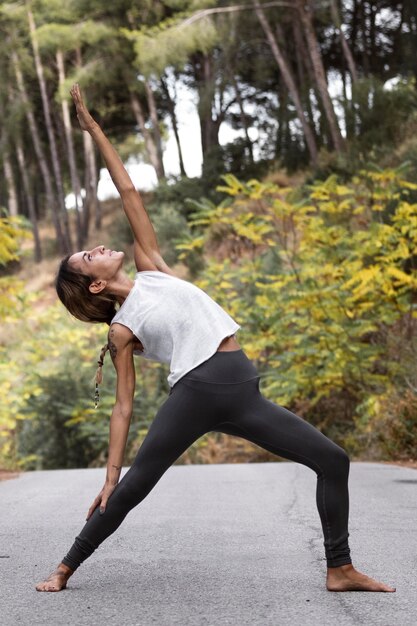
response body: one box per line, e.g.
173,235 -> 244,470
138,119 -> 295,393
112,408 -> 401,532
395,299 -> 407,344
26,0 -> 72,252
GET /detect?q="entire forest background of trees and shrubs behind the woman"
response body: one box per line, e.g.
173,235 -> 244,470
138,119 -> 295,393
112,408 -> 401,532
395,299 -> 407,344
0,0 -> 417,469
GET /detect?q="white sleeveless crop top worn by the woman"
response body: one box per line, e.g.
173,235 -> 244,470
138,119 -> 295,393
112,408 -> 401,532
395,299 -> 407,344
111,270 -> 241,387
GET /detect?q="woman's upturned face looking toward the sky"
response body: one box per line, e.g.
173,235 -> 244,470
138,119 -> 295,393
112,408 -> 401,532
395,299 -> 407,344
68,246 -> 125,281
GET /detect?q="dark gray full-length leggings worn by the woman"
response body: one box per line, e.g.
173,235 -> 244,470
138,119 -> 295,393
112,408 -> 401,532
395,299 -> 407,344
62,349 -> 351,570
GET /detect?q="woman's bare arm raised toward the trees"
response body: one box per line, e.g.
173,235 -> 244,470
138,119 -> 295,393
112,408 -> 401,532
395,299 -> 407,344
71,85 -> 165,271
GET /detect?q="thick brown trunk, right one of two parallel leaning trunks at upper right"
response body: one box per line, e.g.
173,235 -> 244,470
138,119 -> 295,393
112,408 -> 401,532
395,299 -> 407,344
297,0 -> 344,152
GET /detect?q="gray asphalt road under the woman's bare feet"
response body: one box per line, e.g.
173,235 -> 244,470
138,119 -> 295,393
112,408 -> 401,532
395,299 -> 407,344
0,463 -> 417,626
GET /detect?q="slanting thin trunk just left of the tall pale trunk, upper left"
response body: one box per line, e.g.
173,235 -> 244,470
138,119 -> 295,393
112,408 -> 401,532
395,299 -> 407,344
10,47 -> 69,254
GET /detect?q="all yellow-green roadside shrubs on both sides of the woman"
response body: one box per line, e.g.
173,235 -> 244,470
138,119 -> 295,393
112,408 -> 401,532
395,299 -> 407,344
0,170 -> 417,468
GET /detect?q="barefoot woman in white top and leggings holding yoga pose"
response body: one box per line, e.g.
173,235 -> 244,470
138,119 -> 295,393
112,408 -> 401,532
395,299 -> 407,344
36,85 -> 395,591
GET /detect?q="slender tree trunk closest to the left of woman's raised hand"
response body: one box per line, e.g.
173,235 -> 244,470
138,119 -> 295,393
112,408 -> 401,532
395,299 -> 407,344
56,49 -> 84,250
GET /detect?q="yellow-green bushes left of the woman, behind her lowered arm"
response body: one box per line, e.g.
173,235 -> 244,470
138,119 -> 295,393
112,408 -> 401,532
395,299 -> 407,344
0,303 -> 168,469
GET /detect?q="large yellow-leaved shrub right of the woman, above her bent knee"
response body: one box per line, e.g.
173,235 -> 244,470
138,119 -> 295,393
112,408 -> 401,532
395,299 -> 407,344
178,170 -> 417,454
